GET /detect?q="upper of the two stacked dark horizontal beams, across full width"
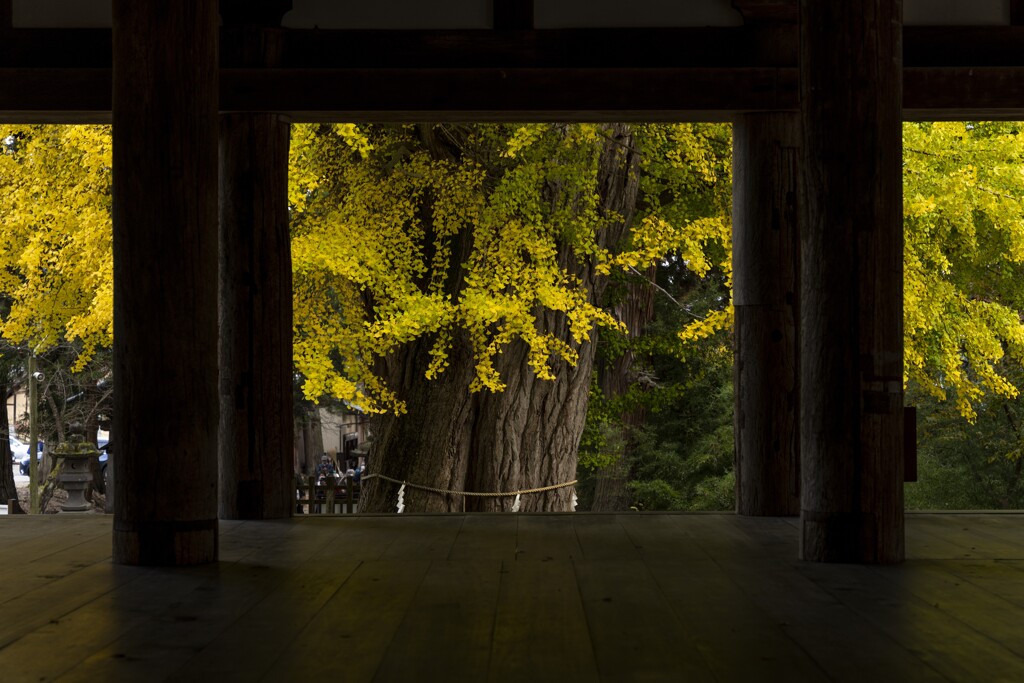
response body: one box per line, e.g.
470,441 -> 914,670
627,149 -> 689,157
12,25 -> 1024,69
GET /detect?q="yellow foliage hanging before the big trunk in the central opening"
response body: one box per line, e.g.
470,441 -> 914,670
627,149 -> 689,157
290,124 -> 730,411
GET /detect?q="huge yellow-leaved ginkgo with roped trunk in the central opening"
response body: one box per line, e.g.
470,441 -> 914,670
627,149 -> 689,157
293,125 -> 729,510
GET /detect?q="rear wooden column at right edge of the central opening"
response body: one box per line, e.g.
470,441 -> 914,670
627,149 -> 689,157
732,113 -> 801,516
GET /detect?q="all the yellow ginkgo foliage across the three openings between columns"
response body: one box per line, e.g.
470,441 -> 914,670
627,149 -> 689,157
8,118 -> 1024,430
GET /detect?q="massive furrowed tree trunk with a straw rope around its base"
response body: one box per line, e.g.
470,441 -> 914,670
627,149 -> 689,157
359,126 -> 638,512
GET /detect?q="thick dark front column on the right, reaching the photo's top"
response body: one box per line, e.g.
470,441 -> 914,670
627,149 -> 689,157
800,0 -> 903,562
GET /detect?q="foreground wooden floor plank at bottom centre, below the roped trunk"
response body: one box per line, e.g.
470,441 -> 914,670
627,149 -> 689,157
487,559 -> 598,683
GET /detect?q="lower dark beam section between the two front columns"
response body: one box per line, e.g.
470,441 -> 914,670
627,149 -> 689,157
221,69 -> 797,119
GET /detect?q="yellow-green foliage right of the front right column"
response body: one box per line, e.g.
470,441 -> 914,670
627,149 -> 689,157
903,122 -> 1024,421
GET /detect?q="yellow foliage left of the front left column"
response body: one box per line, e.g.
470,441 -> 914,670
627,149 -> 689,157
0,126 -> 114,367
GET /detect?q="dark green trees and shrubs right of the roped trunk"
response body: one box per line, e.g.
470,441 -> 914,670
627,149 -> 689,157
581,261 -> 735,510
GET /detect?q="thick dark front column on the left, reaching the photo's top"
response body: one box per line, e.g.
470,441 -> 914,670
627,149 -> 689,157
113,0 -> 218,564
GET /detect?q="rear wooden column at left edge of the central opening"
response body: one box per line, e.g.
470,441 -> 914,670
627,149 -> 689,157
220,114 -> 295,519
